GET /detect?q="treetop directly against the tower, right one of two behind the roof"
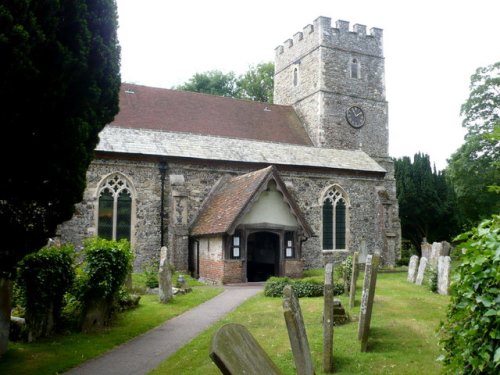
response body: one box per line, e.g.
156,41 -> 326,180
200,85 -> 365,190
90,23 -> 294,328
238,63 -> 274,103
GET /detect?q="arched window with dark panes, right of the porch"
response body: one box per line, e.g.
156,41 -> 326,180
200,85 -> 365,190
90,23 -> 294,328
322,188 -> 347,250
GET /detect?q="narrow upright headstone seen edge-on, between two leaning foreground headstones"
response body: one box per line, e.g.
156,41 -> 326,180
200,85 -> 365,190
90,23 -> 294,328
323,263 -> 333,373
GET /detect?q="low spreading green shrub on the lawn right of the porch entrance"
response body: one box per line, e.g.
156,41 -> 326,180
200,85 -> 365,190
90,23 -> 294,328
264,277 -> 344,298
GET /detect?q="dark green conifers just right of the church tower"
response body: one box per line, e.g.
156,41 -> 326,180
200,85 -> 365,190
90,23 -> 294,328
394,153 -> 459,252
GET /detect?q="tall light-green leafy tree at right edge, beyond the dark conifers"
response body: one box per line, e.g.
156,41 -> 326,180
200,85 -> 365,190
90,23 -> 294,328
446,62 -> 500,224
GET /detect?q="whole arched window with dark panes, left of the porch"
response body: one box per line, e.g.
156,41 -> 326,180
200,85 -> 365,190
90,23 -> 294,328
97,174 -> 132,241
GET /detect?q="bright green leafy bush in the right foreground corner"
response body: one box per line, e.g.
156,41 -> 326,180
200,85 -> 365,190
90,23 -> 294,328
440,215 -> 500,374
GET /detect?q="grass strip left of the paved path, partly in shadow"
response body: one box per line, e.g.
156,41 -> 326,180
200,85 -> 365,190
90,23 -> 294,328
0,276 -> 223,375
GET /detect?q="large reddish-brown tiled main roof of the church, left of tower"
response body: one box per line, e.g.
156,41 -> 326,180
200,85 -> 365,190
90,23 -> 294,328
111,83 -> 312,146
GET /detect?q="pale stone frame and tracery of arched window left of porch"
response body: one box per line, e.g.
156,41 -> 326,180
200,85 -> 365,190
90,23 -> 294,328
94,171 -> 137,246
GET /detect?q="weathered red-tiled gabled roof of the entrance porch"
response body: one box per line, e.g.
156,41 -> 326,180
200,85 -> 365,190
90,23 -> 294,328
191,166 -> 313,236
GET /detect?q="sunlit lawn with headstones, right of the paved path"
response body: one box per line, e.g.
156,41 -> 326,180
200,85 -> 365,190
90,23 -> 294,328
152,269 -> 449,375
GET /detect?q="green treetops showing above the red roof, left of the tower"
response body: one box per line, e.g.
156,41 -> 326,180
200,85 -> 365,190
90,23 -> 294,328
175,63 -> 274,103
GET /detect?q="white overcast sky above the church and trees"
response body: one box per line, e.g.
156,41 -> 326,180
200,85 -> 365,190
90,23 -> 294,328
117,0 -> 500,169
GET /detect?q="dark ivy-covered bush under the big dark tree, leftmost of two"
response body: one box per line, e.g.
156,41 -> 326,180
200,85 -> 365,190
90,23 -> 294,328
17,245 -> 75,341
